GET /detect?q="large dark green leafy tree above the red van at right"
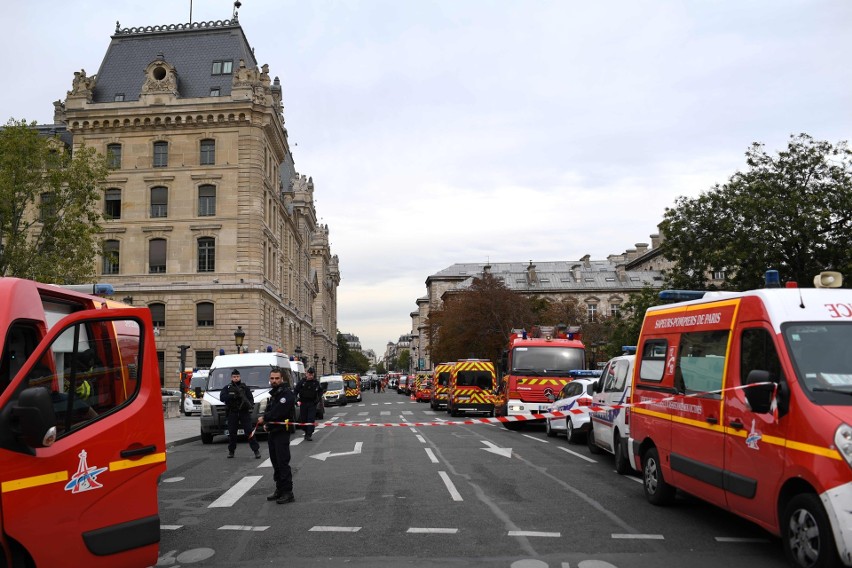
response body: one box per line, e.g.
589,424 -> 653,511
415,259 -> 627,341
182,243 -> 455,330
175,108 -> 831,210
660,134 -> 852,289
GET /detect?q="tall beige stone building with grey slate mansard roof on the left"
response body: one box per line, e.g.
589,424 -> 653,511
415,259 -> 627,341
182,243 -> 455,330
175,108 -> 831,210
49,10 -> 340,386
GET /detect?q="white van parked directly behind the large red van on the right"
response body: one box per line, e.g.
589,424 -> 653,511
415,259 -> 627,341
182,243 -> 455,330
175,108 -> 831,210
586,347 -> 636,475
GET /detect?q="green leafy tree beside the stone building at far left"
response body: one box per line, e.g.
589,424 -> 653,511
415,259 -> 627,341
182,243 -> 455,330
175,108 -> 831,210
0,120 -> 108,284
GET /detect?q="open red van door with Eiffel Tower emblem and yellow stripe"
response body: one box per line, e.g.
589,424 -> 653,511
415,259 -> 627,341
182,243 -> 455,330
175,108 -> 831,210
0,308 -> 166,567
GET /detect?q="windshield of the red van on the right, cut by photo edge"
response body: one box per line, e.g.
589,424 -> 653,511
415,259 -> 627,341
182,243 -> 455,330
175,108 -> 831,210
783,323 -> 852,406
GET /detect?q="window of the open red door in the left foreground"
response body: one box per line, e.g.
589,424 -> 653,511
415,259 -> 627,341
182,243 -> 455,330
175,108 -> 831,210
21,320 -> 141,436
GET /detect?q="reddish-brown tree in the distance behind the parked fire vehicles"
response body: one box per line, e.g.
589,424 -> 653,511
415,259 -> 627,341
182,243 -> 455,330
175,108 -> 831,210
426,274 -> 535,361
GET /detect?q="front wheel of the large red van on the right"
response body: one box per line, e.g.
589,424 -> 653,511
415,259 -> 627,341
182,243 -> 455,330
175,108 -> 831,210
780,493 -> 840,568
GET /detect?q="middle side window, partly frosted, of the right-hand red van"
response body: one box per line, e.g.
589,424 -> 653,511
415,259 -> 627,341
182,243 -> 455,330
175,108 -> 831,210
677,330 -> 729,398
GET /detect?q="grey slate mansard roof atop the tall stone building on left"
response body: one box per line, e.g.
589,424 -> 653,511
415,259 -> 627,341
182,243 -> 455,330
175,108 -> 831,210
93,19 -> 257,103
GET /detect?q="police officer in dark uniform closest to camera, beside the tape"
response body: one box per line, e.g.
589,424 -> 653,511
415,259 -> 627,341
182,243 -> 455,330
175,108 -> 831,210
257,367 -> 296,505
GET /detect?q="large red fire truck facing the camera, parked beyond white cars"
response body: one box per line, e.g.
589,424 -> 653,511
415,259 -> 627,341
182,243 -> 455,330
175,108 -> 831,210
495,326 -> 586,430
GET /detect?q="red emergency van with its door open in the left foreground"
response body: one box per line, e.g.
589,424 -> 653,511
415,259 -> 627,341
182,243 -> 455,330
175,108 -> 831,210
0,278 -> 166,567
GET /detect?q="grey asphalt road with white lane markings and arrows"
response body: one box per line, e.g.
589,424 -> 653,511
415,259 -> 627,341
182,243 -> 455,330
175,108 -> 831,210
157,391 -> 785,568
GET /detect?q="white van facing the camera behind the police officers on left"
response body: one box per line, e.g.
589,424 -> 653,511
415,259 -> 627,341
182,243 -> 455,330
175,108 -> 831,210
201,352 -> 293,444
